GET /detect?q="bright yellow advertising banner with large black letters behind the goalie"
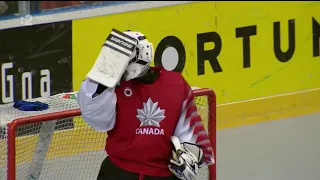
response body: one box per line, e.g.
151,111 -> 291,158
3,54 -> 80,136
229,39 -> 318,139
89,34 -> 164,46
72,1 -> 320,104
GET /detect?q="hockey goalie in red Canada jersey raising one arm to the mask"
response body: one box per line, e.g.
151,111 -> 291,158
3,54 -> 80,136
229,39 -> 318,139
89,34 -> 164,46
77,29 -> 214,180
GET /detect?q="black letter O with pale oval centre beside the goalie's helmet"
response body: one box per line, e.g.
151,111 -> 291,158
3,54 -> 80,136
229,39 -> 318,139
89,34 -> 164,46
154,36 -> 186,72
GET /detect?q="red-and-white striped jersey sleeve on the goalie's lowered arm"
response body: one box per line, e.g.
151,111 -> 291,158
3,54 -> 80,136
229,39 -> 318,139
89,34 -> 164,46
174,81 -> 215,165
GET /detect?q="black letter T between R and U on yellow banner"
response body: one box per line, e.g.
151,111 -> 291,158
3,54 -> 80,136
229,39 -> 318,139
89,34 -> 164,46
236,25 -> 257,68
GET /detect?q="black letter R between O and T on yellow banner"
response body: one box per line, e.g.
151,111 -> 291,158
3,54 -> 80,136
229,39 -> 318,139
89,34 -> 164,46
197,32 -> 222,75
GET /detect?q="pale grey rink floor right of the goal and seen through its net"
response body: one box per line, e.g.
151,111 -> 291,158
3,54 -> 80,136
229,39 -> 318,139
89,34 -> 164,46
12,114 -> 320,180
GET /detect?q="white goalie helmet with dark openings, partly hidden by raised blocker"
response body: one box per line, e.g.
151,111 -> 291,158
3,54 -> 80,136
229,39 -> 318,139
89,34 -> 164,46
124,30 -> 154,81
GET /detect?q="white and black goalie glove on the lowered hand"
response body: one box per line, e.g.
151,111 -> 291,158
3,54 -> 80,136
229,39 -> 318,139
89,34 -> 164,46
168,136 -> 203,180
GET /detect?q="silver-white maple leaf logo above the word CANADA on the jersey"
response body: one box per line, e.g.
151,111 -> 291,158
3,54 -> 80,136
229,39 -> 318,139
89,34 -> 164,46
136,98 -> 165,127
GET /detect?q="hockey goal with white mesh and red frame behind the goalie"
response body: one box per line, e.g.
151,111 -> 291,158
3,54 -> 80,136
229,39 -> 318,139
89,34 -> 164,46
0,89 -> 216,180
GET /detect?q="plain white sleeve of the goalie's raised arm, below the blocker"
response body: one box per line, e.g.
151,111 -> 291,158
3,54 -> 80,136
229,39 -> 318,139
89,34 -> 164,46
77,79 -> 117,132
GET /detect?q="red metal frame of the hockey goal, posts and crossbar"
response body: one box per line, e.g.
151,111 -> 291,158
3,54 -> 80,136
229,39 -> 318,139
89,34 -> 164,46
7,88 -> 216,180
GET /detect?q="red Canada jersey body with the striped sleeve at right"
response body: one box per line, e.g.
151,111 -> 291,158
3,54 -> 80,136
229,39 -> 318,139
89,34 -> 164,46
106,68 -> 214,176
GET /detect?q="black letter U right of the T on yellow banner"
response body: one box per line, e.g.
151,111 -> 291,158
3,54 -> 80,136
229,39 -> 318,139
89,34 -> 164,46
273,19 -> 296,62
